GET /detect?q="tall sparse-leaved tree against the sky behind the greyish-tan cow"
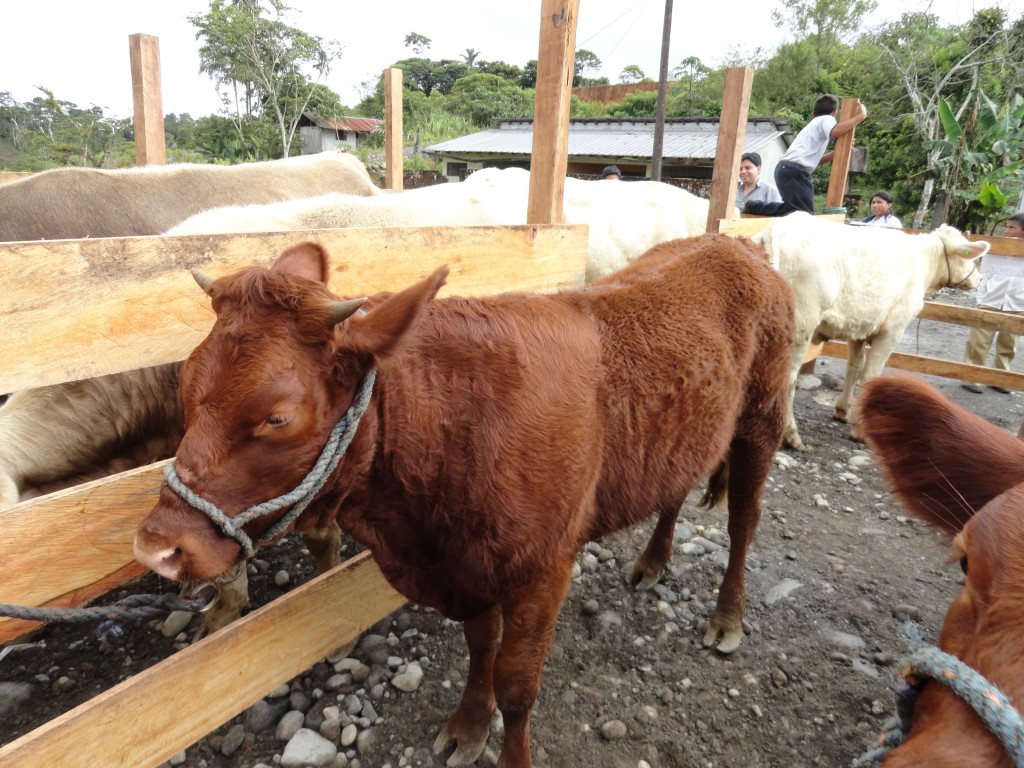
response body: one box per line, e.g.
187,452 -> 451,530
188,0 -> 341,157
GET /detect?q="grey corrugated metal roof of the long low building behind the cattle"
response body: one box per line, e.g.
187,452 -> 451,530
426,119 -> 790,160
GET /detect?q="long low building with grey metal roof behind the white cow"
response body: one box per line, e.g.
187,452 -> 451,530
424,118 -> 794,197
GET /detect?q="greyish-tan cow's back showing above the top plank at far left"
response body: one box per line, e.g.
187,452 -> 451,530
0,153 -> 382,243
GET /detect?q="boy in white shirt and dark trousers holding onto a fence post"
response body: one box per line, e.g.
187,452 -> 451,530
743,93 -> 867,216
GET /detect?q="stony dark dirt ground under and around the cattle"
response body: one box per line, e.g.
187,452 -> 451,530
0,291 -> 1024,768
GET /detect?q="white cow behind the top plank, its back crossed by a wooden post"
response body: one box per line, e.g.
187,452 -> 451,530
167,168 -> 709,282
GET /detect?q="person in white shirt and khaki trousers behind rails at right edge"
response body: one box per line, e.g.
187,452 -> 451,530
961,213 -> 1024,394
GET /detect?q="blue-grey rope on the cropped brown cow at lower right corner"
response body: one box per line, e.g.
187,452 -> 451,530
853,645 -> 1024,768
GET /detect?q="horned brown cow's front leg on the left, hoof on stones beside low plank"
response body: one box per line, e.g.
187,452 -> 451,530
434,605 -> 502,766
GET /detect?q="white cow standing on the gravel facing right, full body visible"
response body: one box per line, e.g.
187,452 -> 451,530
752,212 -> 989,451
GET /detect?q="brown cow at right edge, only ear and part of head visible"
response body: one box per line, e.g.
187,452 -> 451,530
859,376 -> 1024,768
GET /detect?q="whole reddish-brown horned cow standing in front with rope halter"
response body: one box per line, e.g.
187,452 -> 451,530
135,236 -> 794,768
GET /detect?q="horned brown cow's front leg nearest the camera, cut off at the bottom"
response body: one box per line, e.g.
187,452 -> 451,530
495,565 -> 574,768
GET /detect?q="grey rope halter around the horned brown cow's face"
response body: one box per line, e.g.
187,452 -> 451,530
164,369 -> 377,558
